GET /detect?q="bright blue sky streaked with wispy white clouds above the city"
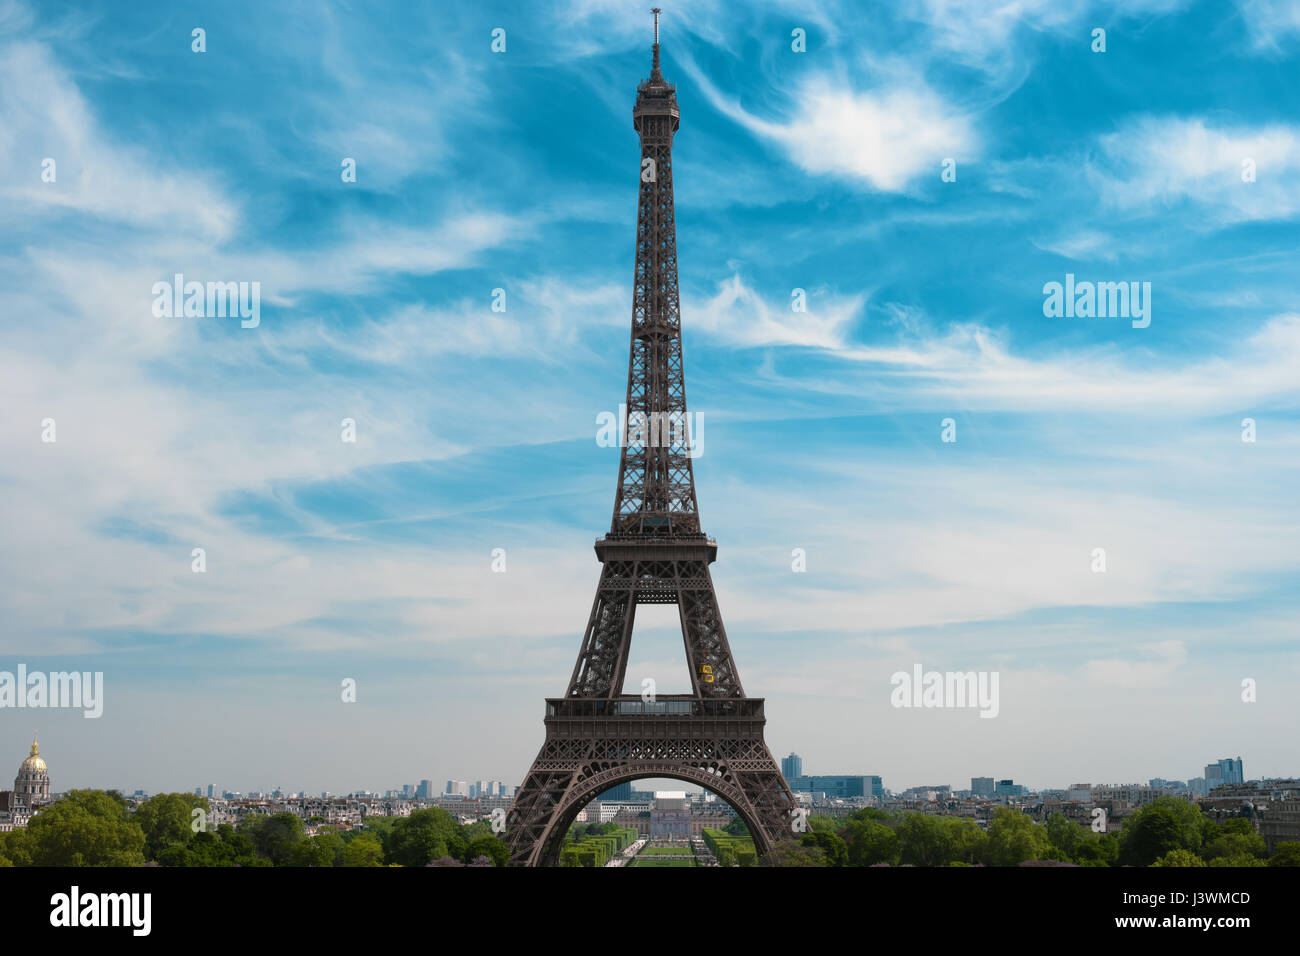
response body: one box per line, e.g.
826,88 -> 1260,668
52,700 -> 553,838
0,0 -> 1300,791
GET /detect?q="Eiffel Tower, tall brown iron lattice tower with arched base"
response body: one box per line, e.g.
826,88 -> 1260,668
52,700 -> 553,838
506,9 -> 797,866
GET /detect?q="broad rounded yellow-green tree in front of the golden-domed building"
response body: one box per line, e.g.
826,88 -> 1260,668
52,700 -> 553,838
16,790 -> 144,866
